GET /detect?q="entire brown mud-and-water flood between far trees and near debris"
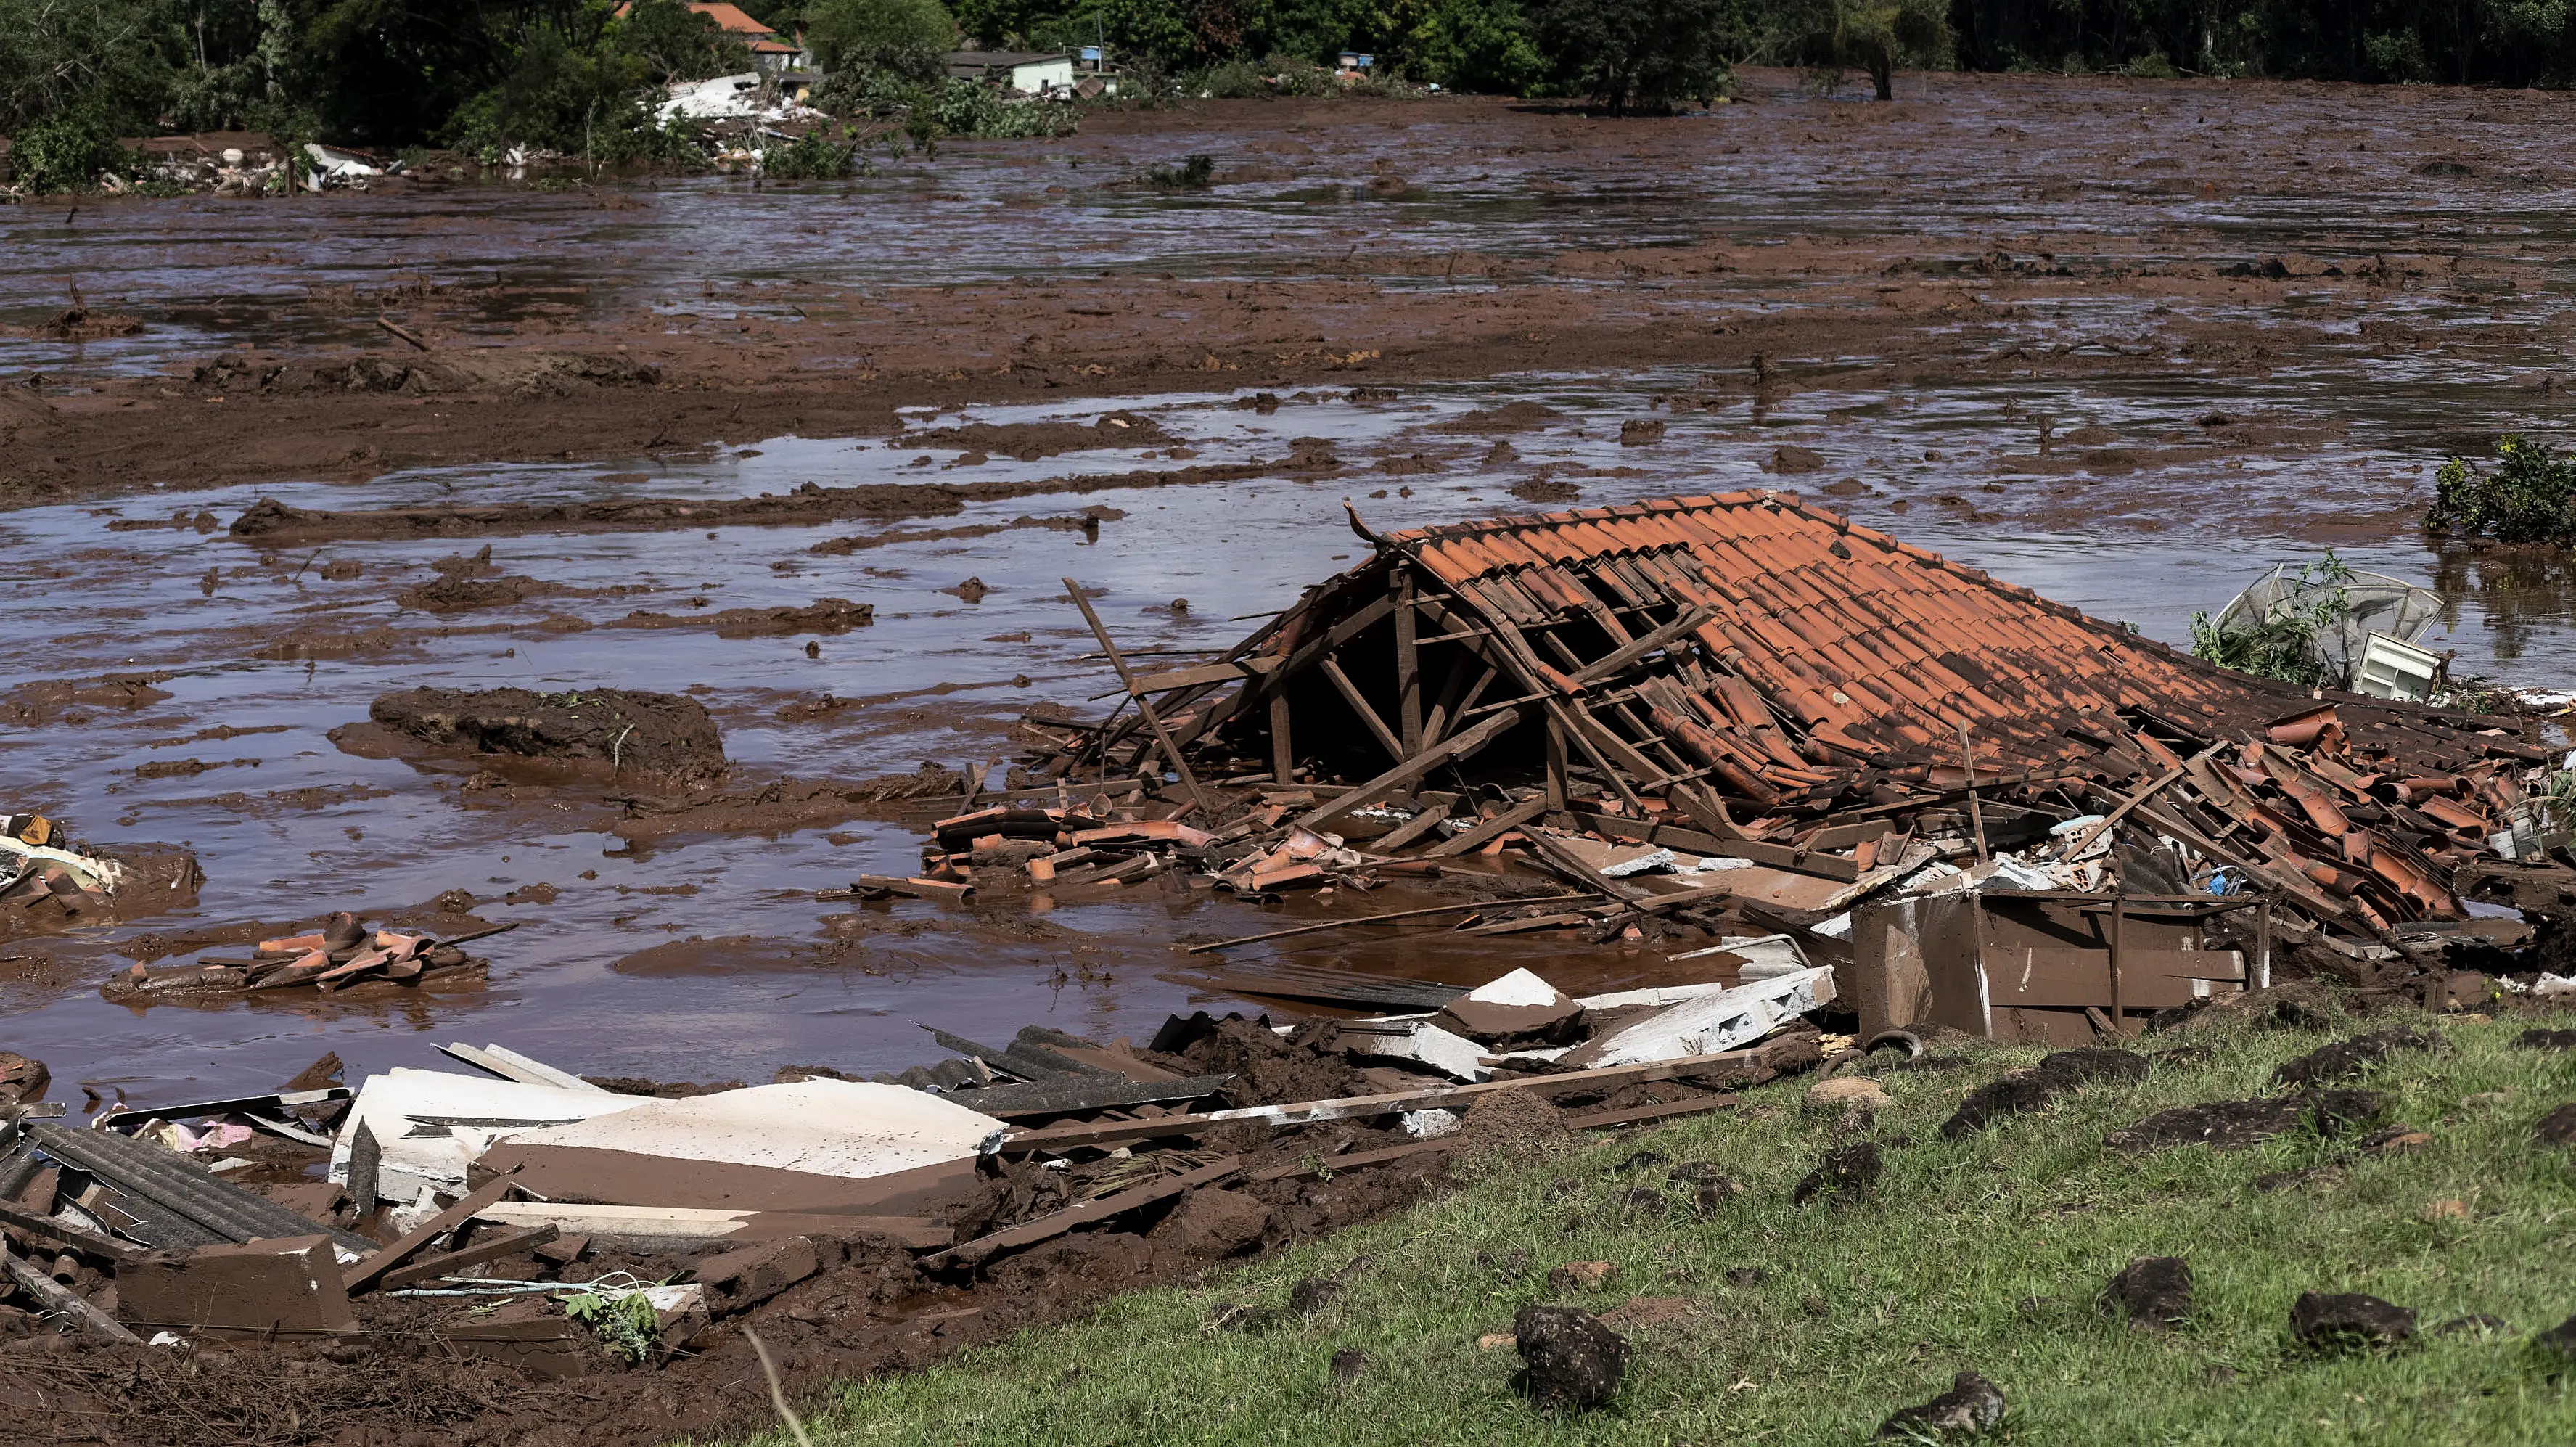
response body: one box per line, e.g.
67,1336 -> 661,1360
0,77 -> 2576,1102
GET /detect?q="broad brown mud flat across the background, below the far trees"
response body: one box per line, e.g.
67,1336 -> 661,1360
0,72 -> 2571,517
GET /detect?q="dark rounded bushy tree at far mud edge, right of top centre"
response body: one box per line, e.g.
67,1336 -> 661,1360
1527,0 -> 1744,116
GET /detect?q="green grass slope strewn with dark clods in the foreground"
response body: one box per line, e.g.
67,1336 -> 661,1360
715,1004 -> 2576,1447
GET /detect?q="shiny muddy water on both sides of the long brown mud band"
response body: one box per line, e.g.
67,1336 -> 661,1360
0,65 -> 2576,1102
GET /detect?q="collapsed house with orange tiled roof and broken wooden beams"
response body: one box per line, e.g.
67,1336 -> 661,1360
994,492 -> 2576,1043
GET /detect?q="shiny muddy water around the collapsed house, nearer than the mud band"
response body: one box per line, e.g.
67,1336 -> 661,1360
0,355 -> 2576,1099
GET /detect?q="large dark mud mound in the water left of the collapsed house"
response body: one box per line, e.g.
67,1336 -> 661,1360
366,687 -> 724,778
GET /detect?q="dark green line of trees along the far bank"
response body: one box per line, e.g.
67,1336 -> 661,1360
15,0 -> 2576,160
